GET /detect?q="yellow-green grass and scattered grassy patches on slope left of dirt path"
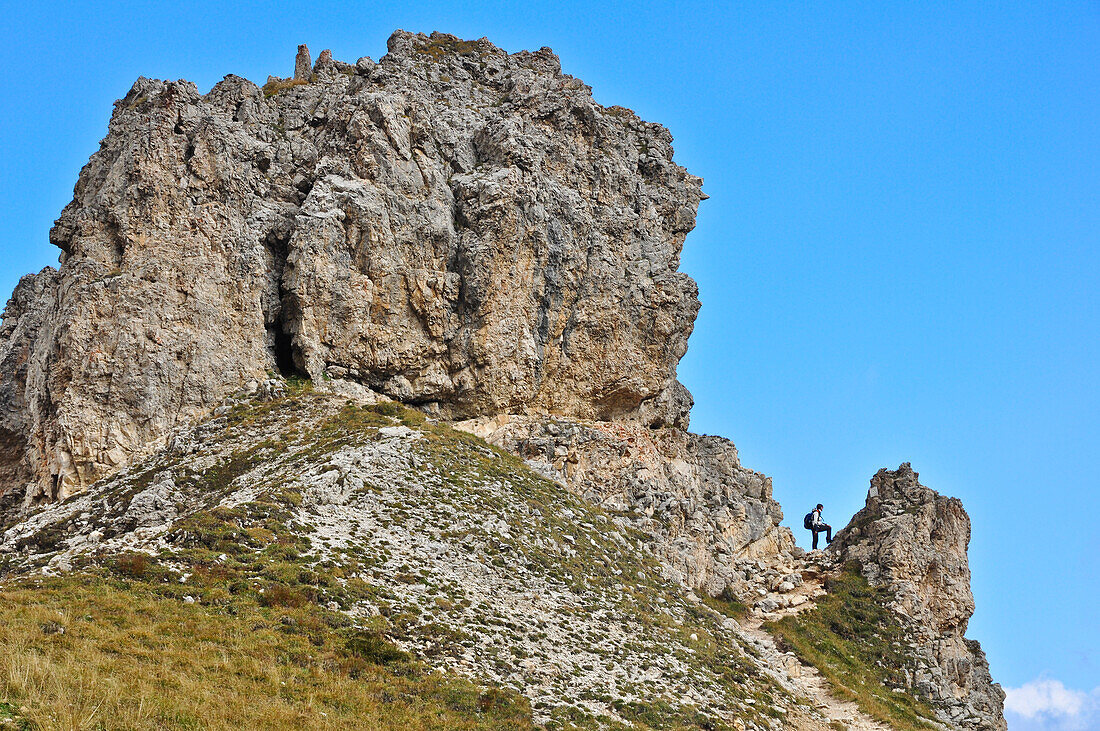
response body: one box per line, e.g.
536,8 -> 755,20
0,389 -> 792,730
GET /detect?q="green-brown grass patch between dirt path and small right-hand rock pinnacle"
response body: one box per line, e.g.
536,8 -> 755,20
765,563 -> 938,731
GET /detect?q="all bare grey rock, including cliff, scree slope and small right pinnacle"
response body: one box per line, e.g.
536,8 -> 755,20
0,32 -> 1004,730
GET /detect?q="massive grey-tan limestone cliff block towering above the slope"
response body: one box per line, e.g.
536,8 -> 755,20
0,32 -> 704,500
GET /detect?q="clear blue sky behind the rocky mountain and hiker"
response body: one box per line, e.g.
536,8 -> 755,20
0,1 -> 1100,729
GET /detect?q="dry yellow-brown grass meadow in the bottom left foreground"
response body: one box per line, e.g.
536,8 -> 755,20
0,576 -> 532,731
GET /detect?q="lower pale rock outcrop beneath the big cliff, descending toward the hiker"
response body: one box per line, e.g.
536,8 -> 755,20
458,416 -> 794,596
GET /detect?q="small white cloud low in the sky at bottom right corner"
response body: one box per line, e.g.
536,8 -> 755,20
1004,677 -> 1100,731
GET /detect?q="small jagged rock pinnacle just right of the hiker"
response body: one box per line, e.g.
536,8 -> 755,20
829,463 -> 1008,731
